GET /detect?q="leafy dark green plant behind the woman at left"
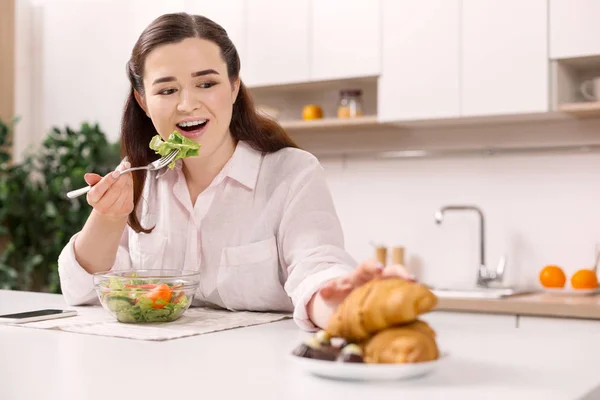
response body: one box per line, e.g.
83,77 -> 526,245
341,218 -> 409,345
0,120 -> 120,293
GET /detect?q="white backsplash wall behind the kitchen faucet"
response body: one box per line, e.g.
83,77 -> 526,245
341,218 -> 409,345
323,142 -> 600,285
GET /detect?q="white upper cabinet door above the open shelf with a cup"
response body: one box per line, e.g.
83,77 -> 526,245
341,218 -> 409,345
550,0 -> 600,59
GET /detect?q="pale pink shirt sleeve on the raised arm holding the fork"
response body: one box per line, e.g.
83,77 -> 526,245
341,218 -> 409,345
58,228 -> 131,306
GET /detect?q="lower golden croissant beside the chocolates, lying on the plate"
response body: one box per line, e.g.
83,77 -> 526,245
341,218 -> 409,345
362,321 -> 439,364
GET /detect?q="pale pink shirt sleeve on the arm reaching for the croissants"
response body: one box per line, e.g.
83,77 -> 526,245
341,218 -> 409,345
278,159 -> 356,331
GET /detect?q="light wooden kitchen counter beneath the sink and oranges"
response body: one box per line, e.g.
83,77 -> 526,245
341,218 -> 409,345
436,293 -> 600,320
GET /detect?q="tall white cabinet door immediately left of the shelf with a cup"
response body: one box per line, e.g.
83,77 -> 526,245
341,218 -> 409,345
461,0 -> 549,116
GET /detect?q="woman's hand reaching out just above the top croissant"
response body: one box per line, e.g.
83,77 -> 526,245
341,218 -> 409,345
319,260 -> 415,304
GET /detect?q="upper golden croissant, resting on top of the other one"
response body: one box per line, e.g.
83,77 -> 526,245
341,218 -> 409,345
326,278 -> 437,342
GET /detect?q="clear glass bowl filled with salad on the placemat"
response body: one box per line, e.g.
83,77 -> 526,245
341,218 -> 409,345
93,269 -> 200,323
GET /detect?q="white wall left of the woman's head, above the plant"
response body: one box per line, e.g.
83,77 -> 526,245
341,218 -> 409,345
15,0 -> 183,155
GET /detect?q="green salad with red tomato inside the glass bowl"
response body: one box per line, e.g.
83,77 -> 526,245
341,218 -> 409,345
100,277 -> 189,322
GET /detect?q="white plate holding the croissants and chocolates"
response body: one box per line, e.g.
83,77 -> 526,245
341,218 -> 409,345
288,353 -> 448,380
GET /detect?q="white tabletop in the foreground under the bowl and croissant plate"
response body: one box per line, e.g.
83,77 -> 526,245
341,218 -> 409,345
0,290 -> 600,400
